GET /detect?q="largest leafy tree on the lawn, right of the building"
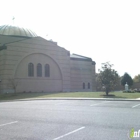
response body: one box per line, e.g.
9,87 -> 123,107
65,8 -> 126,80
98,62 -> 119,95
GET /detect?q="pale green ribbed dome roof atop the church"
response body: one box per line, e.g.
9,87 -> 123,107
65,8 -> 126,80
0,25 -> 37,37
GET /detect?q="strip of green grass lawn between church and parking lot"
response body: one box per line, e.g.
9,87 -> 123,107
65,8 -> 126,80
0,92 -> 140,100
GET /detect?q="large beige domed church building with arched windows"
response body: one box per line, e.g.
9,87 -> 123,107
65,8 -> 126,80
0,25 -> 96,93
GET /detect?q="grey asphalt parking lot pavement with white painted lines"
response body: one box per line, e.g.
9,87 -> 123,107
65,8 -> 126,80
0,100 -> 140,140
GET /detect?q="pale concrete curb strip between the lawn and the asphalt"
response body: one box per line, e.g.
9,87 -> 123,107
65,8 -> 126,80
0,97 -> 140,102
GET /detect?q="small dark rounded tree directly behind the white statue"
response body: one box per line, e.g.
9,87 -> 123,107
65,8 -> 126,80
121,73 -> 133,87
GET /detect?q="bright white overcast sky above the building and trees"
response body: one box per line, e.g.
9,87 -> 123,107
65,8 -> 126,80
0,0 -> 140,77
